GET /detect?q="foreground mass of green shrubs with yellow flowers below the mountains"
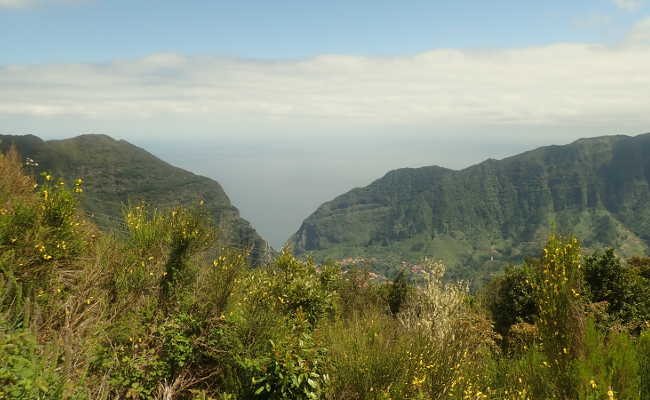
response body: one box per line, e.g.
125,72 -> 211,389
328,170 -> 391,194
0,142 -> 650,400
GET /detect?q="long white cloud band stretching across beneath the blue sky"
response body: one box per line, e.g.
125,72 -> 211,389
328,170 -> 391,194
0,39 -> 650,130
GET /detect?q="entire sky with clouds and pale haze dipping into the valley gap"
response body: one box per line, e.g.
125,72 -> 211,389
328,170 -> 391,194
0,0 -> 650,248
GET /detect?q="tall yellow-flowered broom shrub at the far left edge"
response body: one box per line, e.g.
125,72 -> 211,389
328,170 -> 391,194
0,162 -> 90,328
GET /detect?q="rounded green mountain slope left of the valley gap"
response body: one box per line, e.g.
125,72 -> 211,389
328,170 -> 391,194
0,135 -> 269,263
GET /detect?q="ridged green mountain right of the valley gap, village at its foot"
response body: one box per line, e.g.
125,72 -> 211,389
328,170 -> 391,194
289,134 -> 650,277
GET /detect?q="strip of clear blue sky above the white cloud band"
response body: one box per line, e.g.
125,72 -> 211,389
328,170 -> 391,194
0,0 -> 646,64
